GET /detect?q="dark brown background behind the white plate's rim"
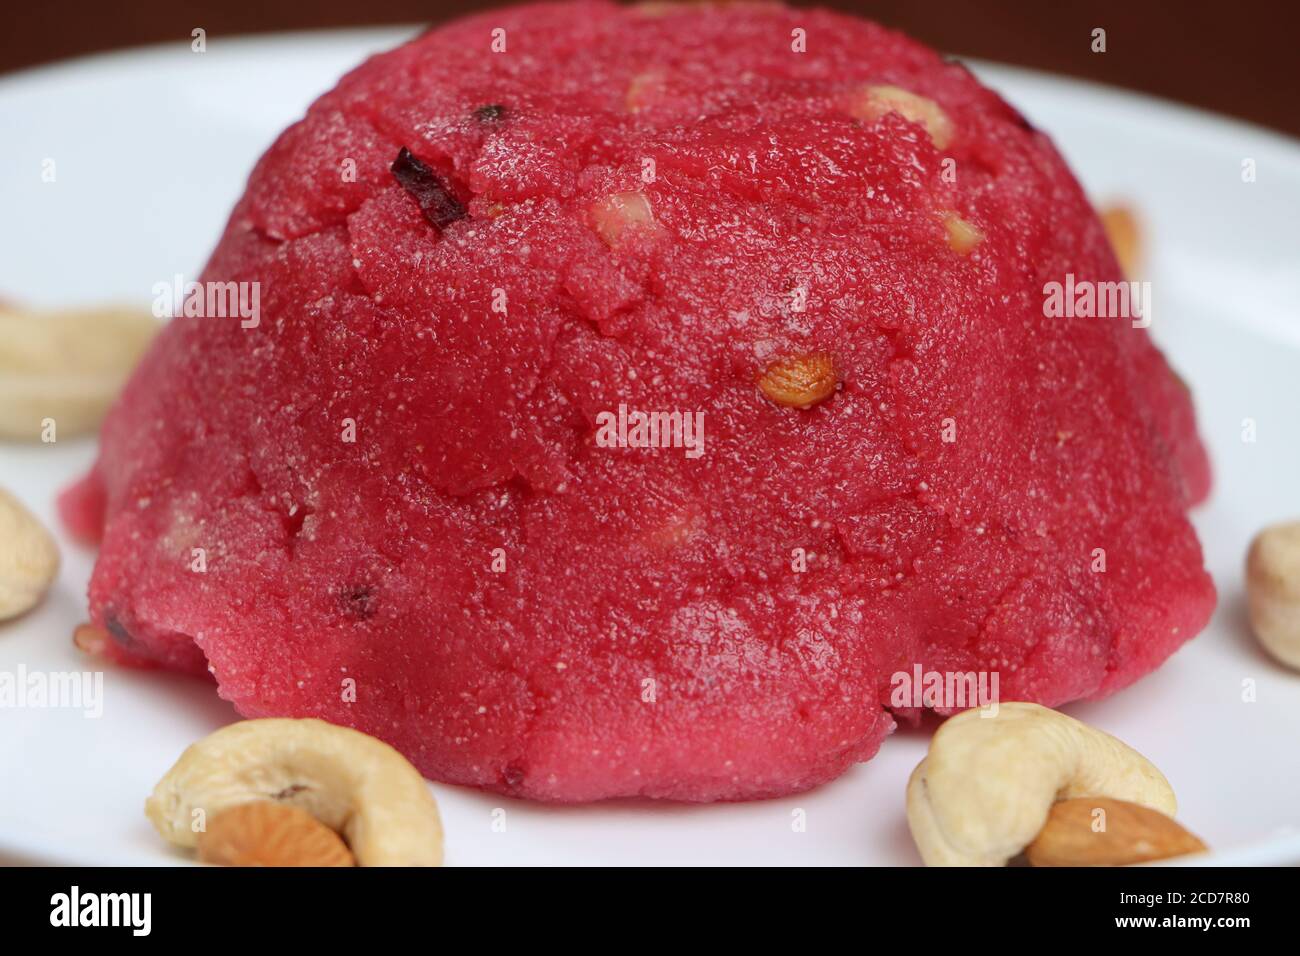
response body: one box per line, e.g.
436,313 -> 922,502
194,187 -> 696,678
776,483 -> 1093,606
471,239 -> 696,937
0,0 -> 1300,135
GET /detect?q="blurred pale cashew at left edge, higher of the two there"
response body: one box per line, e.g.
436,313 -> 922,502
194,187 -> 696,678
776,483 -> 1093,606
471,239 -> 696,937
0,308 -> 161,441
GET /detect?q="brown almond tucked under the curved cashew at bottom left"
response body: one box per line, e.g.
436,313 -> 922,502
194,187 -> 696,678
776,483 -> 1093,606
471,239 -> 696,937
199,800 -> 356,866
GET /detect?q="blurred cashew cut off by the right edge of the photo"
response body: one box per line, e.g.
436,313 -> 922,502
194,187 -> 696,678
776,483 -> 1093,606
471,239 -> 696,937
1245,522 -> 1300,670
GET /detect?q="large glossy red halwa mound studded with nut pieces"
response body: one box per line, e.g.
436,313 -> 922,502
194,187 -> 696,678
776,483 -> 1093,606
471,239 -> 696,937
64,3 -> 1214,801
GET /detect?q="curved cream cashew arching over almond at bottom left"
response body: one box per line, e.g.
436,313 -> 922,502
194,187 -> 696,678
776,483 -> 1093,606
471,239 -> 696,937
144,718 -> 442,866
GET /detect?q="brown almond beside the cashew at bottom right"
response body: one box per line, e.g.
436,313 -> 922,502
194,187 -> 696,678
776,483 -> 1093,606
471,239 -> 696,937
1024,797 -> 1205,866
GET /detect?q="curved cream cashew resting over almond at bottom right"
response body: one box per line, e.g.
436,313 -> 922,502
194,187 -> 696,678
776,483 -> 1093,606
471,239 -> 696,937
907,702 -> 1177,866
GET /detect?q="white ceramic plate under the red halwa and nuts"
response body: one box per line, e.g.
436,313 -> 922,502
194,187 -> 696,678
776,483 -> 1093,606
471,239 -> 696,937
0,30 -> 1300,865
